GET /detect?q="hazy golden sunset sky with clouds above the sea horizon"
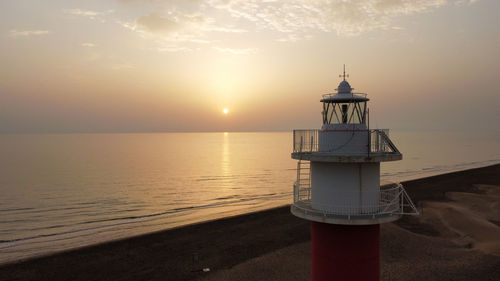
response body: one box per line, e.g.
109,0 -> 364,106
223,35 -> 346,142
0,0 -> 500,133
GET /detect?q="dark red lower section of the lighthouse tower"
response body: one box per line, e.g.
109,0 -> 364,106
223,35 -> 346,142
311,222 -> 380,281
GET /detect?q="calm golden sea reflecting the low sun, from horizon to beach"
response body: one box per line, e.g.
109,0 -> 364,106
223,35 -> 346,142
0,132 -> 500,263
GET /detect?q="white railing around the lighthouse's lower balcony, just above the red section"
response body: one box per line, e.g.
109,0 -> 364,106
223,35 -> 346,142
293,182 -> 418,215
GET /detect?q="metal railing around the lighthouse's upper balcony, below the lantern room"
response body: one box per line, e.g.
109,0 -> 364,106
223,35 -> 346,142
293,129 -> 400,154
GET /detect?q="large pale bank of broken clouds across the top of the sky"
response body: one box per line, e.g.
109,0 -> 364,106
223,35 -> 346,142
115,0 -> 479,49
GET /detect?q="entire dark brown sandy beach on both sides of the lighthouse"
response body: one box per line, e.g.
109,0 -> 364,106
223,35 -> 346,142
0,164 -> 500,280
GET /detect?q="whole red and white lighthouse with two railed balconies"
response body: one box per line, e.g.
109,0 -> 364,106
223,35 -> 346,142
291,65 -> 418,281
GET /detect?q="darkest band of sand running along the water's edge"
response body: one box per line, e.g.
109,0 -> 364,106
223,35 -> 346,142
0,164 -> 500,280
